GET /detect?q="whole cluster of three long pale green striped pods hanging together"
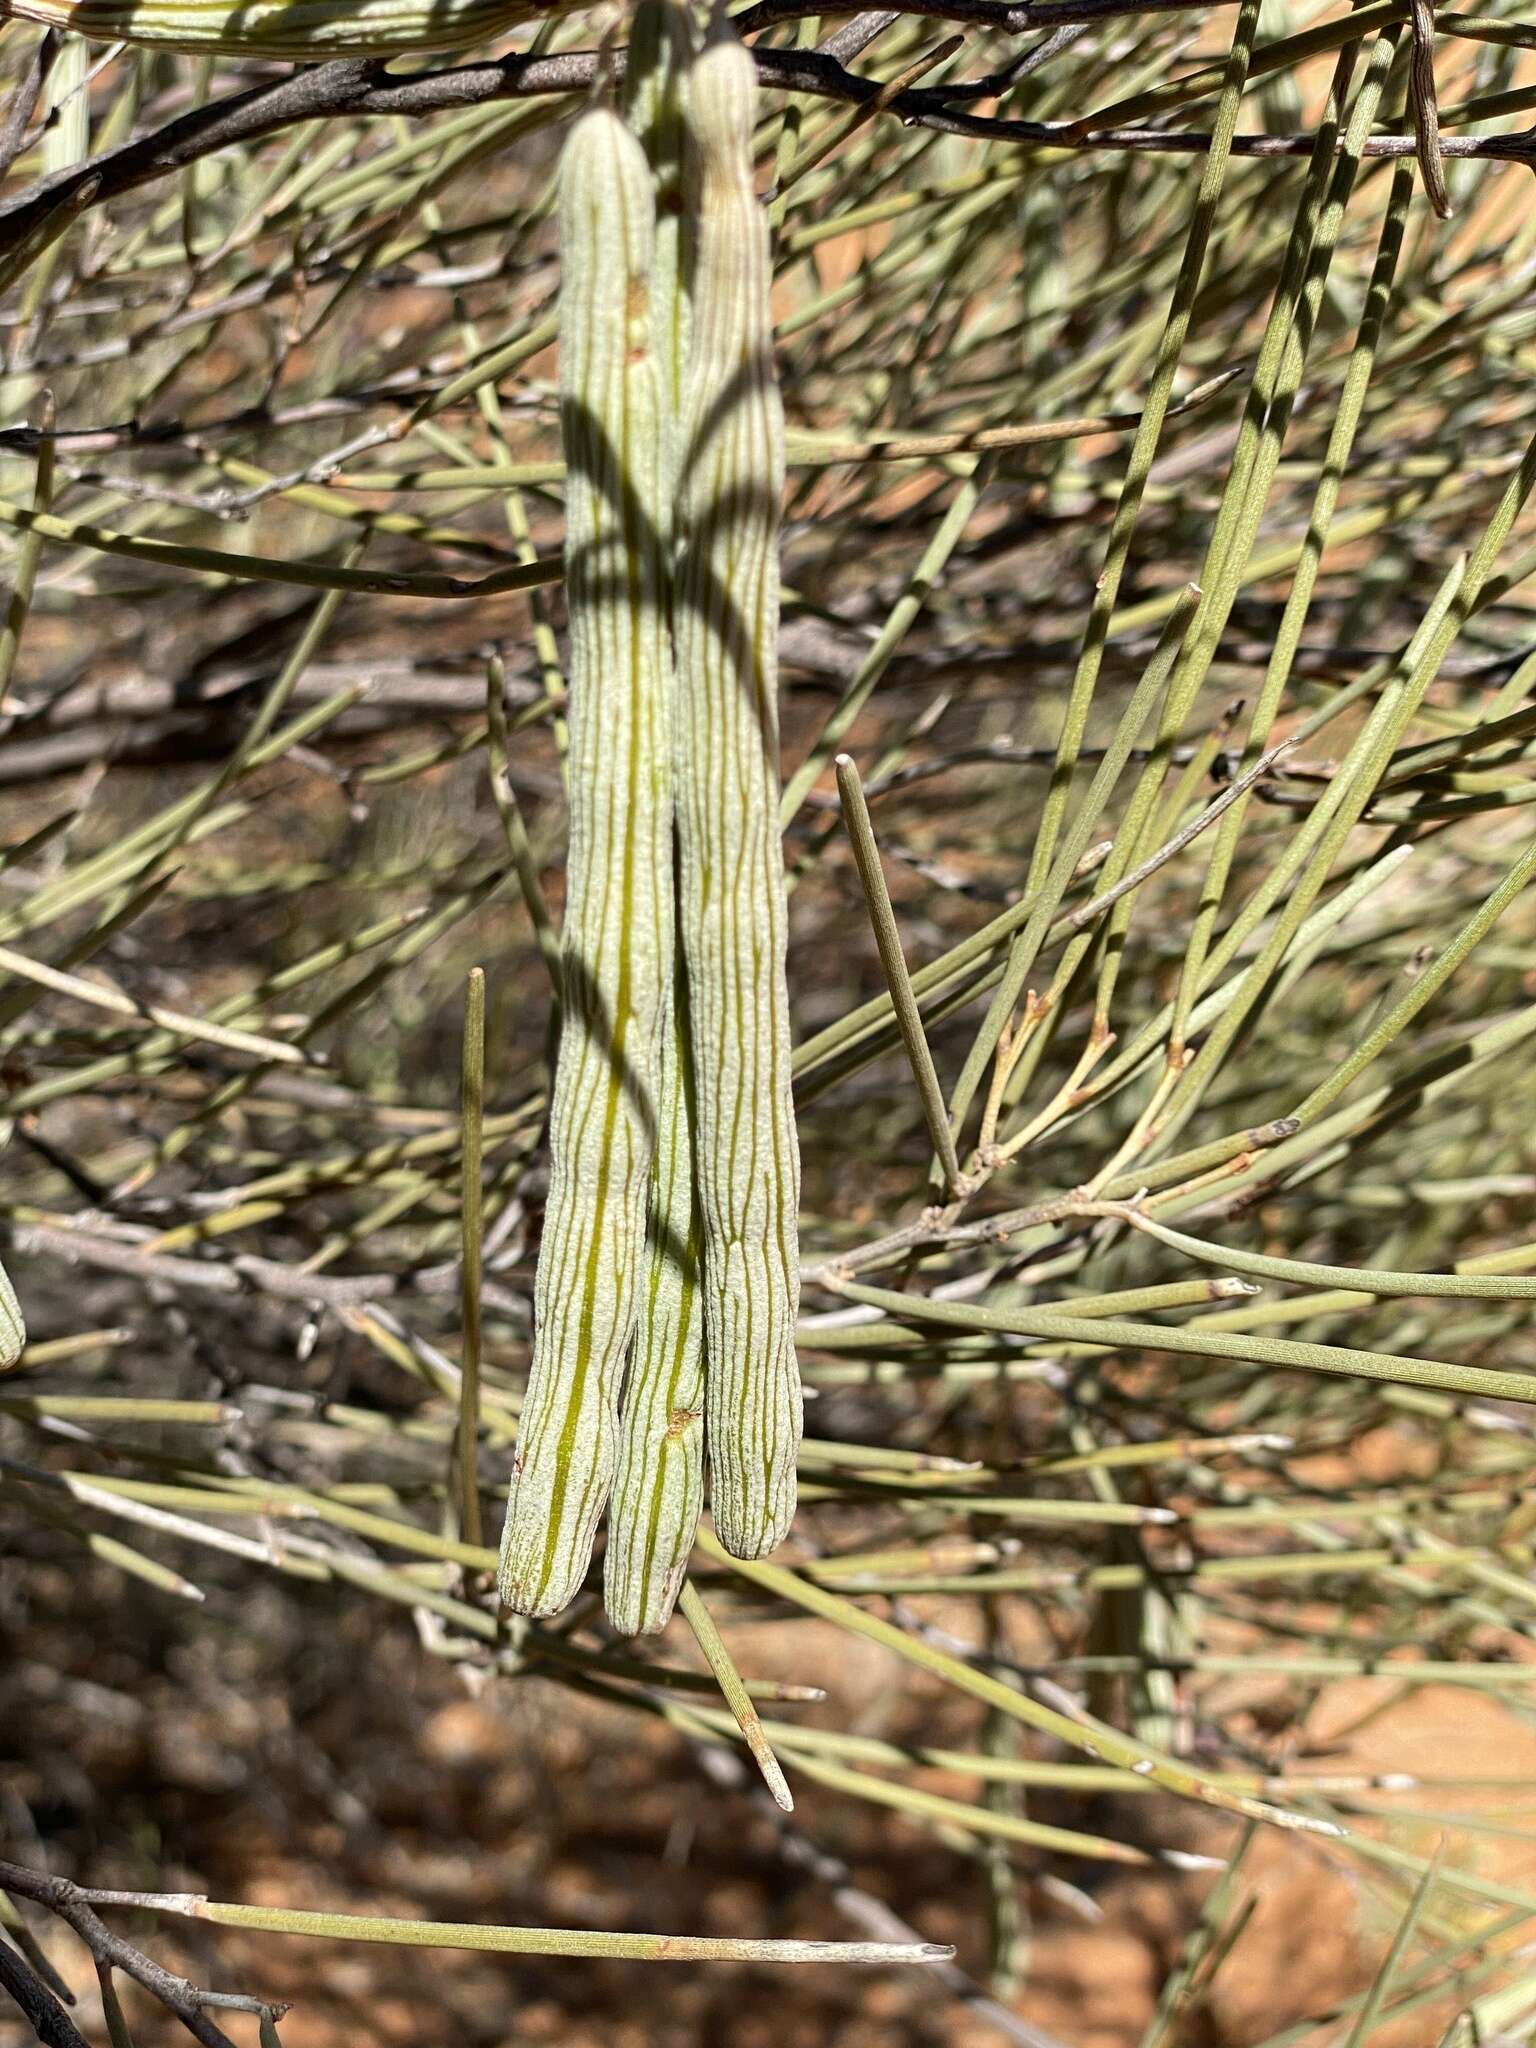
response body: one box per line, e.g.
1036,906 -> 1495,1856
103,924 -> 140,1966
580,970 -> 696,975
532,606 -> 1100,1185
500,0 -> 801,1634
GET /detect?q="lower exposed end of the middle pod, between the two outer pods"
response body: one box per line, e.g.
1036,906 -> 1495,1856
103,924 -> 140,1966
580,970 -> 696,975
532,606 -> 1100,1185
602,942 -> 705,1636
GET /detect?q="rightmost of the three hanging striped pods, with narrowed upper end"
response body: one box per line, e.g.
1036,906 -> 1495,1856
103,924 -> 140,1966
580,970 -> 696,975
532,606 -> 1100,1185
674,37 -> 801,1556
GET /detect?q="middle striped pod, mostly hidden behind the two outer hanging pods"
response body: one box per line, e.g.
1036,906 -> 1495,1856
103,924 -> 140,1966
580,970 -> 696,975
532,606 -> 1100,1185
604,0 -> 705,1636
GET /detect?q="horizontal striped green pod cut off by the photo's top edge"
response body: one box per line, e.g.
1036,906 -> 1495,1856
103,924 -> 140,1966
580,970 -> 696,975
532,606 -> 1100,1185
0,0 -> 561,61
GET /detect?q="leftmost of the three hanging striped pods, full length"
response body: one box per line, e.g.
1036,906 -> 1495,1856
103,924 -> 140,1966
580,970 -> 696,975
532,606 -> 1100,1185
500,109 -> 674,1614
